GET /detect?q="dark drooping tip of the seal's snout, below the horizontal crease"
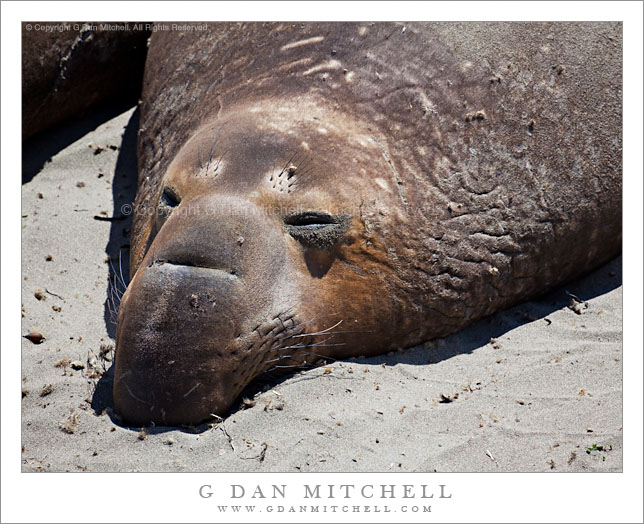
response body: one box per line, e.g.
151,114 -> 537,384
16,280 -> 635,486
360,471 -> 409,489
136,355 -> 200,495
114,265 -> 243,425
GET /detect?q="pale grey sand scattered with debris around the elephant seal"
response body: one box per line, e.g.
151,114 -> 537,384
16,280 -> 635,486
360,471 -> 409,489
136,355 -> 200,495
21,103 -> 623,472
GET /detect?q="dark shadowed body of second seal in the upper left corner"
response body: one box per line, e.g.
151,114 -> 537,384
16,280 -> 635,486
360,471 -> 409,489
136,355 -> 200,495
22,22 -> 150,139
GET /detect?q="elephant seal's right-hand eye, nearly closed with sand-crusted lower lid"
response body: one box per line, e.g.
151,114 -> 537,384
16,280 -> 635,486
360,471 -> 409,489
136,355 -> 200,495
284,211 -> 351,249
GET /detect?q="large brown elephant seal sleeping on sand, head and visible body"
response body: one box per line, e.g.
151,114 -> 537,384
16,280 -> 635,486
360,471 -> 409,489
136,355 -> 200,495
114,23 -> 621,425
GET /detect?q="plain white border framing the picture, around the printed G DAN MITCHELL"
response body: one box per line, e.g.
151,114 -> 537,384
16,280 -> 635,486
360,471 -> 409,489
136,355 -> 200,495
0,2 -> 643,522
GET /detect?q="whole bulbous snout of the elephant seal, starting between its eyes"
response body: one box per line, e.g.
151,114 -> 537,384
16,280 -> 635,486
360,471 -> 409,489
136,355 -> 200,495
114,197 -> 291,425
